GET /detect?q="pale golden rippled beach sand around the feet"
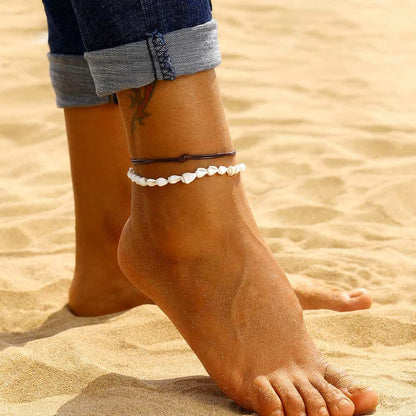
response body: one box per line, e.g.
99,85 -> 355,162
0,0 -> 416,416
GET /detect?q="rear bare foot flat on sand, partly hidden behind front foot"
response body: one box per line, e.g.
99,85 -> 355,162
69,241 -> 371,316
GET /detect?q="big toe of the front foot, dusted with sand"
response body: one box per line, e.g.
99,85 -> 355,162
325,367 -> 379,416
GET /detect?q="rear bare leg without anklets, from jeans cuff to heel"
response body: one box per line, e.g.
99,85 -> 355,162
65,104 -> 151,316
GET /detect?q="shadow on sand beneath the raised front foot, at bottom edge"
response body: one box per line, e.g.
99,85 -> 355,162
56,373 -> 255,416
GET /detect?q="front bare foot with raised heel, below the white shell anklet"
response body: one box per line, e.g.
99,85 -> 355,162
119,172 -> 378,416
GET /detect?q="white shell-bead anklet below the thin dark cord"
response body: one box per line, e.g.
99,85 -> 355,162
127,163 -> 246,186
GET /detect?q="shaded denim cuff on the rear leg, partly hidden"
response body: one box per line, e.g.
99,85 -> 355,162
48,53 -> 111,108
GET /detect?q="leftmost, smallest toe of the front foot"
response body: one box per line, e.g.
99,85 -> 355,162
252,377 -> 284,416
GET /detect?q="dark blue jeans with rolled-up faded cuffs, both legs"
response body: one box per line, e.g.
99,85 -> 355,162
43,0 -> 221,108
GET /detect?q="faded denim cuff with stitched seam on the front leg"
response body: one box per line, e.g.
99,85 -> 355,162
84,19 -> 221,97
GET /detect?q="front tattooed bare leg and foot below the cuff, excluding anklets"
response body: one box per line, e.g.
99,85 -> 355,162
115,71 -> 378,416
